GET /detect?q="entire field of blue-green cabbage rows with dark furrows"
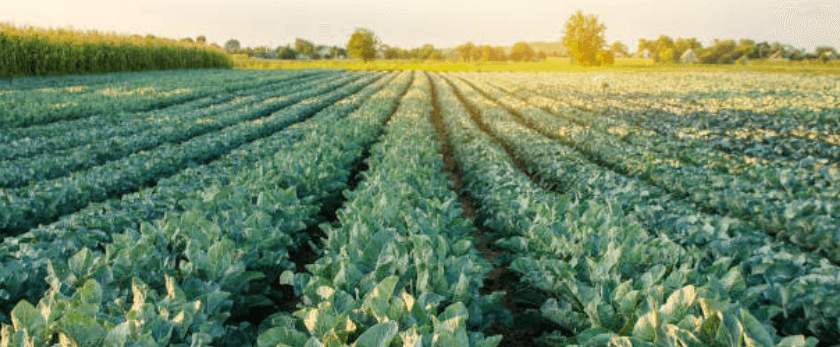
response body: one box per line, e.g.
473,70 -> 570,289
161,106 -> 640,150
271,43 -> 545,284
0,70 -> 840,347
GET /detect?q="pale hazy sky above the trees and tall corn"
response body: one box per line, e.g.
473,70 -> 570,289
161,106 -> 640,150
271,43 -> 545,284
0,0 -> 840,51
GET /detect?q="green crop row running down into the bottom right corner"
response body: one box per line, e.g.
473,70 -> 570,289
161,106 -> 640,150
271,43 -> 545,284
450,73 -> 840,341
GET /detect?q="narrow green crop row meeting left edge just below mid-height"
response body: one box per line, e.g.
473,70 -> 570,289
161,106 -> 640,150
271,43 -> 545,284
0,74 -> 370,235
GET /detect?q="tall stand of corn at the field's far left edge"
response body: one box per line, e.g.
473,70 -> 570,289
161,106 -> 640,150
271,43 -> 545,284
0,25 -> 233,77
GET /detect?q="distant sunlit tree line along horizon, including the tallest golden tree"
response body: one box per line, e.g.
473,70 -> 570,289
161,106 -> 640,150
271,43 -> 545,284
220,19 -> 837,66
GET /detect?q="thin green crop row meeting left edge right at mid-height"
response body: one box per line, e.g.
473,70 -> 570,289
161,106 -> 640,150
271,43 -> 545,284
0,70 -> 346,188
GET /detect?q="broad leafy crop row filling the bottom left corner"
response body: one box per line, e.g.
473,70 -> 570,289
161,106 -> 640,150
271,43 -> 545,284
3,74 -> 410,346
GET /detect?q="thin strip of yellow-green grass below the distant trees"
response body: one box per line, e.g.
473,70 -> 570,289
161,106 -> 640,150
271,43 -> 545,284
233,55 -> 840,75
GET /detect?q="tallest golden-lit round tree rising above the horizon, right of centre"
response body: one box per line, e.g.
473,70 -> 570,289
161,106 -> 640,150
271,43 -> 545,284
562,10 -> 607,66
